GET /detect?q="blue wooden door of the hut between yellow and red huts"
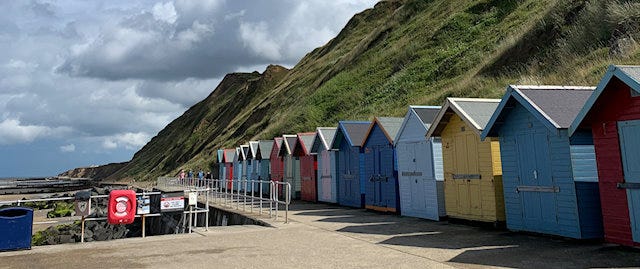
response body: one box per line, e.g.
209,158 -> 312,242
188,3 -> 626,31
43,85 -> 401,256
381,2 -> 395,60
516,132 -> 558,231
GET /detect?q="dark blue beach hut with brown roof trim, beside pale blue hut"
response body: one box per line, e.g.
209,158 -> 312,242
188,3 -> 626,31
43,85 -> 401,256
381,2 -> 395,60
362,117 -> 404,213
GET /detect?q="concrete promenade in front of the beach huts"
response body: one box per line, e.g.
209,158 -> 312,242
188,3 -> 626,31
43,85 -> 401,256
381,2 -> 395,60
0,202 -> 640,268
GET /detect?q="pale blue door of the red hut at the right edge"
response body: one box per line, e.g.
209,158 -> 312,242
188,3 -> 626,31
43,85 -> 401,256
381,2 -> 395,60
618,120 -> 640,242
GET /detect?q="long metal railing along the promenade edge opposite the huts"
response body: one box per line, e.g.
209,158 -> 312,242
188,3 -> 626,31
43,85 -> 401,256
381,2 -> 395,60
157,177 -> 291,223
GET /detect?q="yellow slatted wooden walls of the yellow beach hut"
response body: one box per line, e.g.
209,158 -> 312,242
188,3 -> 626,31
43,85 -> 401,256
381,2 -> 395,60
441,115 -> 505,222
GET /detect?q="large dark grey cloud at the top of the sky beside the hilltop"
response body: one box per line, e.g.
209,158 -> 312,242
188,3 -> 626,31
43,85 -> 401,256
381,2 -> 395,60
56,0 -> 373,81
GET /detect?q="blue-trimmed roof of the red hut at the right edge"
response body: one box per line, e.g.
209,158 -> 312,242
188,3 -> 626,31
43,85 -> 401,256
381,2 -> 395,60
569,65 -> 640,135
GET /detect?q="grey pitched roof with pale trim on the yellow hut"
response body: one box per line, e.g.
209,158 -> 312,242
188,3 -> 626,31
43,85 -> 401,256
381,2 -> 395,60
426,97 -> 500,137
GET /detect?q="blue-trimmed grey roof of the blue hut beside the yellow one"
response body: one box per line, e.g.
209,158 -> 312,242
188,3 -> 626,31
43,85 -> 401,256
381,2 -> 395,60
480,85 -> 595,139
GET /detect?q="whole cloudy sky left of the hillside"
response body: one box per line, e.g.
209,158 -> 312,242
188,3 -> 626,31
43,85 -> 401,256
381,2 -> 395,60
0,0 -> 376,177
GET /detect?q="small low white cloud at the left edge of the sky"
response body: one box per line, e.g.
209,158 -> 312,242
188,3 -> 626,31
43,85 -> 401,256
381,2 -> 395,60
0,119 -> 71,145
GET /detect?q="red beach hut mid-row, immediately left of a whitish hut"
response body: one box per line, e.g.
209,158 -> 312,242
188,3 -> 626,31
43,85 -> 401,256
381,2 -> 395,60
293,132 -> 318,202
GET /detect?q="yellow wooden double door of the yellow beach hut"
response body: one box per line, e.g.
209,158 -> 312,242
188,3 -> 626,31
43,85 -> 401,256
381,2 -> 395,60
453,133 -> 482,217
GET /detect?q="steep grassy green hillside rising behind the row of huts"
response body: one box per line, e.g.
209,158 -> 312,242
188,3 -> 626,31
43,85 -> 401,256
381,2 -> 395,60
63,0 -> 640,180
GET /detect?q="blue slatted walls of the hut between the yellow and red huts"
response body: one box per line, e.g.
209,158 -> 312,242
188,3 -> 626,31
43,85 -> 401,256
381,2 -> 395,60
498,102 -> 602,239
